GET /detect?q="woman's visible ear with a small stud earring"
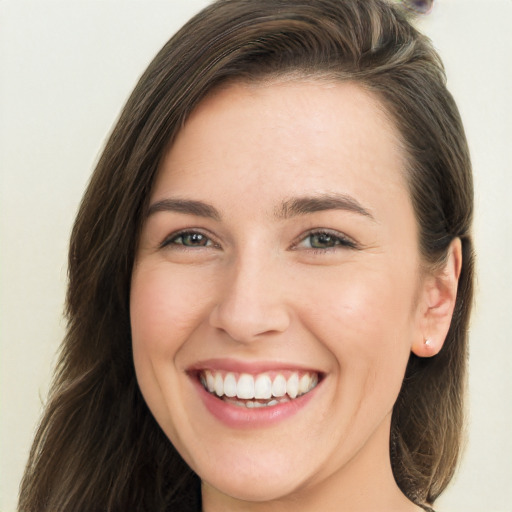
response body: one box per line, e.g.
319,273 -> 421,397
411,238 -> 462,357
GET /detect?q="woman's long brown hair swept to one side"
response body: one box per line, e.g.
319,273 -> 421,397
19,0 -> 473,512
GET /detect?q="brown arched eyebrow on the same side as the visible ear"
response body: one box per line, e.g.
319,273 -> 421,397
276,194 -> 375,221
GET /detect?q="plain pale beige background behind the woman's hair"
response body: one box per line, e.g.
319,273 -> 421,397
0,0 -> 512,512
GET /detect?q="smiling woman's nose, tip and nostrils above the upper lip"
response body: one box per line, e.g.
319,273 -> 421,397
210,255 -> 290,343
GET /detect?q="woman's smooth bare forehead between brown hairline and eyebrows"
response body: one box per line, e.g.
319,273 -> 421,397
153,79 -> 407,221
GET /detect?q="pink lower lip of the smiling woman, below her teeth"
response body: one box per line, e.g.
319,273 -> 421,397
192,378 -> 321,429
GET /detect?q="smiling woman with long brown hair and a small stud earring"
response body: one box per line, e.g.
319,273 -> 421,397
19,0 -> 472,511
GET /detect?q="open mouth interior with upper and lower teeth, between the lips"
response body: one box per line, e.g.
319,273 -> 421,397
198,370 -> 321,408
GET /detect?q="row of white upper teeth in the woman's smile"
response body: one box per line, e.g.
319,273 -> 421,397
200,370 -> 318,400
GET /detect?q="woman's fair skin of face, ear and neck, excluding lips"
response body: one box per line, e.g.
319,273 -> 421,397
131,80 -> 460,512
